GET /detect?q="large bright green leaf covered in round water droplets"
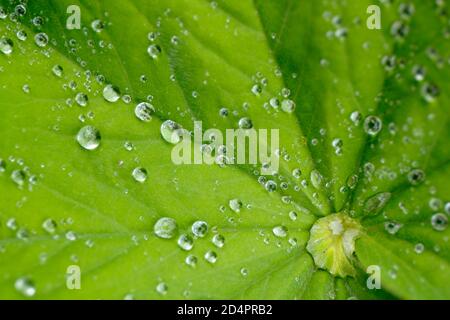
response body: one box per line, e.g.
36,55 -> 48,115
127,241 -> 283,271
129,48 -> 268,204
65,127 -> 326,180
0,0 -> 450,299
